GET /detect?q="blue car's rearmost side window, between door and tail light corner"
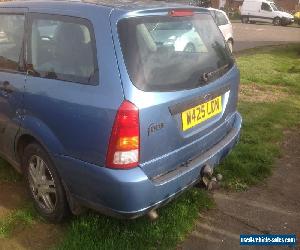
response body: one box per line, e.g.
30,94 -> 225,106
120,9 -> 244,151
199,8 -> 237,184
28,14 -> 98,85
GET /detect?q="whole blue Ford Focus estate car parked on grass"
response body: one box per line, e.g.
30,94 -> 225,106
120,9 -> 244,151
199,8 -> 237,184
0,0 -> 241,222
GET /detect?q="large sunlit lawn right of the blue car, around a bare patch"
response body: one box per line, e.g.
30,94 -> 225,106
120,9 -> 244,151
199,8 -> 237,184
219,45 -> 300,190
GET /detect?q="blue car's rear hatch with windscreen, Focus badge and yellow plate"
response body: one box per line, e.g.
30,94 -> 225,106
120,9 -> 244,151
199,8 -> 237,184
111,8 -> 239,178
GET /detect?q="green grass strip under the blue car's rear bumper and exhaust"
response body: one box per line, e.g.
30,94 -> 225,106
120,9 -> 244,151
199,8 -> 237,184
58,189 -> 213,250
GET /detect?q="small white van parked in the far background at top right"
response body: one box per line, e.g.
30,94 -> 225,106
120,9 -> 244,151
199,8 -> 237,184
240,0 -> 294,26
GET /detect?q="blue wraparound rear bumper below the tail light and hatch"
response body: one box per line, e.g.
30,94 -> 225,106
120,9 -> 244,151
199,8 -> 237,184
54,113 -> 242,218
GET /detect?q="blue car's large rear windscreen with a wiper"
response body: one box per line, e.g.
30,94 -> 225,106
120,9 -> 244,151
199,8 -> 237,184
118,13 -> 233,91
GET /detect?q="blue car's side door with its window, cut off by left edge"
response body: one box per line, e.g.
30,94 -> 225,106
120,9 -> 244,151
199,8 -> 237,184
0,8 -> 27,160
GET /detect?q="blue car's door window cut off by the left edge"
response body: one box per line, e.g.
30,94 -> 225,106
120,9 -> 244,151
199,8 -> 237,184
0,14 -> 25,71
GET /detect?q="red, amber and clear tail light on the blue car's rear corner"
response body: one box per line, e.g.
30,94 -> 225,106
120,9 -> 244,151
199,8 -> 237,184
106,101 -> 140,169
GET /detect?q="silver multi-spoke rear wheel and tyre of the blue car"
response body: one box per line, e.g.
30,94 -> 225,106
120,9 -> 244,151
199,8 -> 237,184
22,143 -> 70,223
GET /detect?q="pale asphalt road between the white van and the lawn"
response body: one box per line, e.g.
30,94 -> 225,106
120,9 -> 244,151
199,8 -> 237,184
233,23 -> 300,52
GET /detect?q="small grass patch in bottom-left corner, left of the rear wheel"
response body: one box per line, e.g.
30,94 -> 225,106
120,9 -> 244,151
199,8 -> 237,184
0,204 -> 38,239
